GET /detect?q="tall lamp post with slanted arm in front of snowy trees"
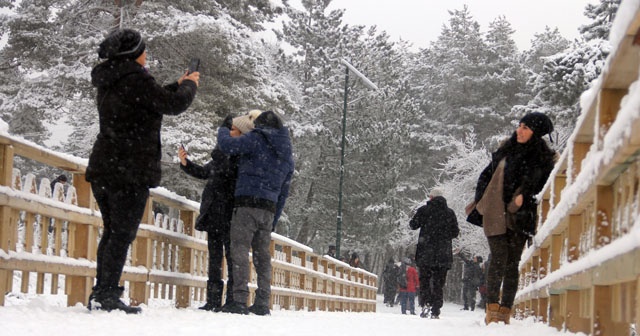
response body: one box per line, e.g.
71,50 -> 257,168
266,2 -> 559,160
336,59 -> 378,258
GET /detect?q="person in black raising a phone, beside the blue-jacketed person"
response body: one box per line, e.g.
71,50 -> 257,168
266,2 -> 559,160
178,116 -> 253,312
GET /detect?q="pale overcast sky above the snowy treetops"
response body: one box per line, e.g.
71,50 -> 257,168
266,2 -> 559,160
324,0 -> 598,50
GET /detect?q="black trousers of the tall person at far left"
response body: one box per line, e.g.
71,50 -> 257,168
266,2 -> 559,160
91,181 -> 149,290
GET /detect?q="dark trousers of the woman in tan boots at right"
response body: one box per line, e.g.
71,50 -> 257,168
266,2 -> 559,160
487,229 -> 527,308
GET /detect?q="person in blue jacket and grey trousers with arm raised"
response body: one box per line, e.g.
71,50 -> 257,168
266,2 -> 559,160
218,111 -> 294,315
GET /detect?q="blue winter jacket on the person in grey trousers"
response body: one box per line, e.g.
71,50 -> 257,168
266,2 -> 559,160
218,112 -> 294,230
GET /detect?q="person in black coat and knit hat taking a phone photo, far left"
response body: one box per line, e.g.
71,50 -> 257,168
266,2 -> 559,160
86,29 -> 200,313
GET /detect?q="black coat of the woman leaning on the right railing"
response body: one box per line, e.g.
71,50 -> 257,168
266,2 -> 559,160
474,132 -> 555,235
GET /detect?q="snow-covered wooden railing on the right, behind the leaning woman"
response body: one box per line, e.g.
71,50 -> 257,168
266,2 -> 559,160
516,1 -> 640,336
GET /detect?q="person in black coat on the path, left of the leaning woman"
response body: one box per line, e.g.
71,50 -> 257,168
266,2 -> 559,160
409,189 -> 460,319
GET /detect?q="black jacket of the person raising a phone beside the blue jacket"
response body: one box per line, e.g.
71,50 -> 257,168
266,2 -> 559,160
180,147 -> 238,234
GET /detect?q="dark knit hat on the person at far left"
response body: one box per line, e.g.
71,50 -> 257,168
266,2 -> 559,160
98,29 -> 145,59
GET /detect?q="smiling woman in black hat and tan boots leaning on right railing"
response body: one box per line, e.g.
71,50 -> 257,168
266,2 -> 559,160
474,112 -> 555,324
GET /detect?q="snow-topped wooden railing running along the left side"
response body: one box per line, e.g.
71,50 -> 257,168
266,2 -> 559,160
0,132 -> 377,311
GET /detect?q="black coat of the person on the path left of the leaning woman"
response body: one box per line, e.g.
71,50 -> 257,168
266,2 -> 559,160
409,196 -> 460,269
